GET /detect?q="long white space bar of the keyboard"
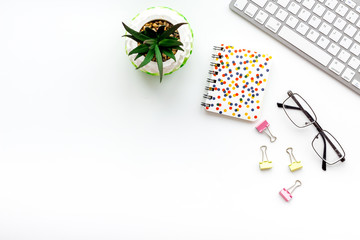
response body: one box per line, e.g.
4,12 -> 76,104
279,26 -> 332,66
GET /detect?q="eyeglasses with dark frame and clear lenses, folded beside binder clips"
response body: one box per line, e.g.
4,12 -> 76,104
277,91 -> 345,171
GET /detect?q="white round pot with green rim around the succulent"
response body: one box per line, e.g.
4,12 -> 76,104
125,7 -> 193,75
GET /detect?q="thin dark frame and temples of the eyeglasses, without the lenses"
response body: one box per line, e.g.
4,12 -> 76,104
277,91 -> 345,171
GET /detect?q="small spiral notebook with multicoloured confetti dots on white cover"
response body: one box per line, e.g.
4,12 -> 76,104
202,44 -> 272,121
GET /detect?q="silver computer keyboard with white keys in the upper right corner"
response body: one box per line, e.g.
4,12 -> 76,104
230,0 -> 360,94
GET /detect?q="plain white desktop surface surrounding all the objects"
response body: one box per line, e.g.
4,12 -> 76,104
0,0 -> 360,240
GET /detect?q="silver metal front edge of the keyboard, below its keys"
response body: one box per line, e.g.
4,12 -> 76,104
229,0 -> 360,95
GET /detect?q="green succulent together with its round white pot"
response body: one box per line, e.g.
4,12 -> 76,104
123,7 -> 193,82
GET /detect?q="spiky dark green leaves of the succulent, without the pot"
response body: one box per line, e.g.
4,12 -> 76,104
123,23 -> 187,82
